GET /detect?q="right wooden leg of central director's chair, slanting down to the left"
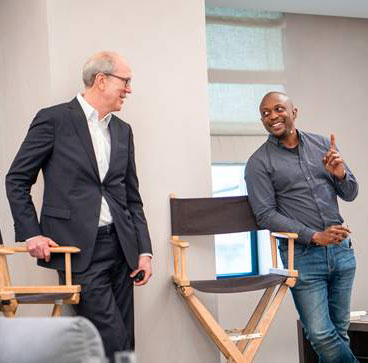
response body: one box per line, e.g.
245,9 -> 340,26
244,284 -> 289,362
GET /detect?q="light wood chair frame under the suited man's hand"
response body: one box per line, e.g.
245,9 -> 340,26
0,245 -> 81,317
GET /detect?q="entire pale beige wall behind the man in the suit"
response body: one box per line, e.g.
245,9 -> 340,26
0,0 -> 219,363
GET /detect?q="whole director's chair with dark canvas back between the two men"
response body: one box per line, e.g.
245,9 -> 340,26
170,195 -> 298,363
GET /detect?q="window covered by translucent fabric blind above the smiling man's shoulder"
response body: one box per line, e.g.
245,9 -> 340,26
206,6 -> 285,135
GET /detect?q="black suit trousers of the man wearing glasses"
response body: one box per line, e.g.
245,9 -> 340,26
59,227 -> 134,357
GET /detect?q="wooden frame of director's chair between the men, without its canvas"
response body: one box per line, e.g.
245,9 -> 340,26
170,195 -> 298,363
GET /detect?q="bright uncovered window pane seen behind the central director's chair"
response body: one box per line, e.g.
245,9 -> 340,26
212,164 -> 258,278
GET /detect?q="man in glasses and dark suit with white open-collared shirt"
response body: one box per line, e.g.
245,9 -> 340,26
6,52 -> 152,357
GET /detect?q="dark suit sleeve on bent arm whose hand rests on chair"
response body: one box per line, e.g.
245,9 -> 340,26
6,110 -> 54,241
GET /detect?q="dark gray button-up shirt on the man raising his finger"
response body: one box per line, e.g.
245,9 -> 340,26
245,130 -> 358,244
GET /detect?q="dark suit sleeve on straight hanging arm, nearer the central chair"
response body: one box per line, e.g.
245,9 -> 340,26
126,126 -> 152,254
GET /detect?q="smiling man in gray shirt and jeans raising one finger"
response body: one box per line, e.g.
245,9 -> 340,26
245,92 -> 358,363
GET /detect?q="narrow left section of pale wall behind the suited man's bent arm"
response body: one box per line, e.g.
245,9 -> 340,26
0,0 -> 56,315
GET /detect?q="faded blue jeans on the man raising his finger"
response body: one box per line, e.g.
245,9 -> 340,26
279,239 -> 358,363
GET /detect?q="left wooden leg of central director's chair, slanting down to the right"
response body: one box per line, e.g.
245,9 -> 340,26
180,287 -> 247,363
